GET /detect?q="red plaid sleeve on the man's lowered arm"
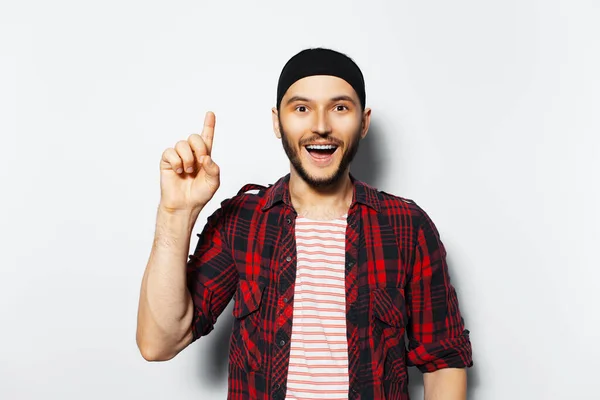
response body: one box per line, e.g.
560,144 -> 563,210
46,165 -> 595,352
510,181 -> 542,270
405,210 -> 473,372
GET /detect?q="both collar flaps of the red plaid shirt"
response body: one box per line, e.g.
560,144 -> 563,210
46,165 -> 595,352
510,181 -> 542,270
262,174 -> 380,212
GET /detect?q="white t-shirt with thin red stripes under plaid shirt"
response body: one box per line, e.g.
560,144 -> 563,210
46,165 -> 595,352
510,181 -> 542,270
286,215 -> 348,400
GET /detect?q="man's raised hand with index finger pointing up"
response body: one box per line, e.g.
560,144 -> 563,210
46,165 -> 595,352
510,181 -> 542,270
160,111 -> 221,212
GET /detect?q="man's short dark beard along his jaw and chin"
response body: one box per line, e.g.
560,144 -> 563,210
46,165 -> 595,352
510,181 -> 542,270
279,120 -> 362,188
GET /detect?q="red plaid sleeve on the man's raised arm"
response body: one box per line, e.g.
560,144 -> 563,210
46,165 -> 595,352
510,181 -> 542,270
186,201 -> 238,341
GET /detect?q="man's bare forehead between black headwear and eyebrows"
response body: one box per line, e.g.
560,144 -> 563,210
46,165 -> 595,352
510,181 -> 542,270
283,75 -> 358,100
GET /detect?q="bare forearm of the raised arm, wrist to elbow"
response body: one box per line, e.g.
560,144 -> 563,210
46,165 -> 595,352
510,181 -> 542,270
136,206 -> 200,360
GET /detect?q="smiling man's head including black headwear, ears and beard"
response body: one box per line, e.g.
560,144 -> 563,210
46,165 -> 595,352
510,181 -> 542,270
272,48 -> 371,187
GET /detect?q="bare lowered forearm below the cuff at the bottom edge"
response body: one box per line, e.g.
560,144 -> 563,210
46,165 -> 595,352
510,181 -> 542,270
423,368 -> 467,400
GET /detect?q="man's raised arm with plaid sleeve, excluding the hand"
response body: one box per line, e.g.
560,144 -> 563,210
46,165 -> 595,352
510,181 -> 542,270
137,202 -> 237,361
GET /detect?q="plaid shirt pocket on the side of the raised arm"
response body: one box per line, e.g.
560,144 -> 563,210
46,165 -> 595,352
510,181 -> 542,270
230,279 -> 265,371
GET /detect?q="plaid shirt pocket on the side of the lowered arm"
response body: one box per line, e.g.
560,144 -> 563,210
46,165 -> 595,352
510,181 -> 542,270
370,287 -> 407,382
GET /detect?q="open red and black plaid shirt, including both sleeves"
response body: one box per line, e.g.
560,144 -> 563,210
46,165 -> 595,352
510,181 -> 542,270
187,174 -> 473,400
